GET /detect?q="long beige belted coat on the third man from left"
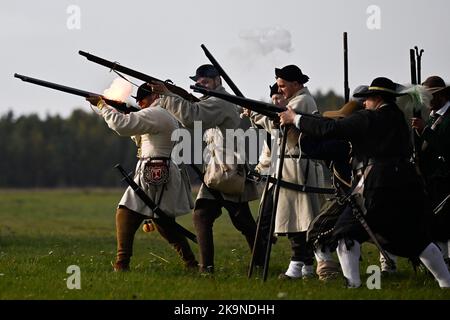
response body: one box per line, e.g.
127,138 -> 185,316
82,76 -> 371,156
252,87 -> 325,234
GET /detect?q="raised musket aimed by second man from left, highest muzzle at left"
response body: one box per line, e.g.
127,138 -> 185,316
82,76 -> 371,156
78,50 -> 199,102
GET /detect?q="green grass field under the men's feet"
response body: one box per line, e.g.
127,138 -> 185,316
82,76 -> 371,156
0,190 -> 450,300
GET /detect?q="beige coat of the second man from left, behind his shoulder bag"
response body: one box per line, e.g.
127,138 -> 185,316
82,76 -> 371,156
161,86 -> 258,202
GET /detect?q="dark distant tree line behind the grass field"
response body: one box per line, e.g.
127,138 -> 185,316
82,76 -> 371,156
0,91 -> 343,188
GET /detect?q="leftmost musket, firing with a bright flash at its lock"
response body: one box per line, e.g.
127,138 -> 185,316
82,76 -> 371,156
14,73 -> 140,113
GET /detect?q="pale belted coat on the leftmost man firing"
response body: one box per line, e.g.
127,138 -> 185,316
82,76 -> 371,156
102,101 -> 194,217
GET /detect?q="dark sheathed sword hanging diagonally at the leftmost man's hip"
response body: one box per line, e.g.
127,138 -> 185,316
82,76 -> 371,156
115,164 -> 197,243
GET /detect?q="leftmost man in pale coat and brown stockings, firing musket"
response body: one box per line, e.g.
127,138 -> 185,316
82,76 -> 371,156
87,84 -> 198,271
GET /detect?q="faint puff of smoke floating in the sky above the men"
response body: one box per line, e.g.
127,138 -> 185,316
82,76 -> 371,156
239,27 -> 294,56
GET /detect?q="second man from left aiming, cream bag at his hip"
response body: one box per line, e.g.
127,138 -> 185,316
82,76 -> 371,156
151,64 -> 263,273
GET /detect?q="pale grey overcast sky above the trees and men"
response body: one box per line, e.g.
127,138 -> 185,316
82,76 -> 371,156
0,0 -> 450,116
